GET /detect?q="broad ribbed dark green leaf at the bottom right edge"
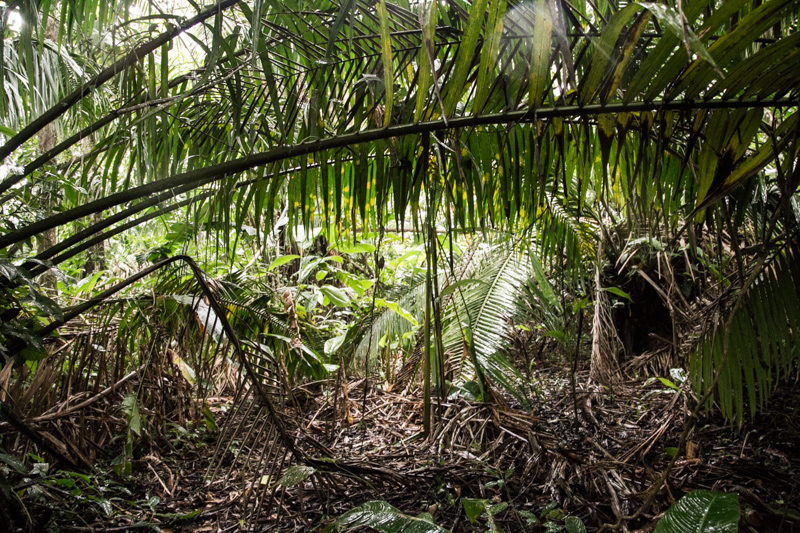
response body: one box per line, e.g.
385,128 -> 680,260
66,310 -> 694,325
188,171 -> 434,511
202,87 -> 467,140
656,490 -> 740,533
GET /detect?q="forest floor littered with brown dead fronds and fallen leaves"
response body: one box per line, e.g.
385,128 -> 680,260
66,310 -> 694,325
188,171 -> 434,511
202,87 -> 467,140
6,368 -> 800,532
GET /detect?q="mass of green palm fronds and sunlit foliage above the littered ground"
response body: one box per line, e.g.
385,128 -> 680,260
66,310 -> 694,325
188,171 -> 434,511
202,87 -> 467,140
0,0 -> 800,470
